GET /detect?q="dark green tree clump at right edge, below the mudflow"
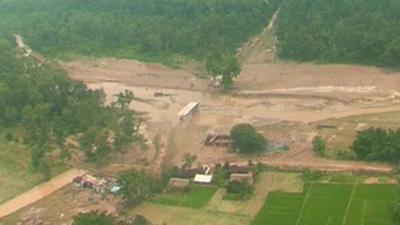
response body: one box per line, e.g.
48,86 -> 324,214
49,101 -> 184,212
352,128 -> 400,163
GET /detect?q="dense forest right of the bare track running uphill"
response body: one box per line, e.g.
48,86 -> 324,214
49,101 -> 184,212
277,0 -> 400,66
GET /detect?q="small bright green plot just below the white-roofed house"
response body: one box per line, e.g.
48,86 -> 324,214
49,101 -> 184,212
150,186 -> 218,209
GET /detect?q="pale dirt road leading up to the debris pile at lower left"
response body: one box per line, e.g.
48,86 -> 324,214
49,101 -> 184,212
0,169 -> 87,218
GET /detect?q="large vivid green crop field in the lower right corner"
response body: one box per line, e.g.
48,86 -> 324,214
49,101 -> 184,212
252,183 -> 398,225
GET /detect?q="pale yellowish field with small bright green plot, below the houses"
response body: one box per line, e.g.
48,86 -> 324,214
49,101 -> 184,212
133,172 -> 303,225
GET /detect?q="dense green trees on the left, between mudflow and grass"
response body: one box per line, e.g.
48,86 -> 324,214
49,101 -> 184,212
0,40 -> 137,170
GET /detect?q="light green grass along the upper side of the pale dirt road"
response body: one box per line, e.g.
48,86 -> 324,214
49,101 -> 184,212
0,143 -> 67,204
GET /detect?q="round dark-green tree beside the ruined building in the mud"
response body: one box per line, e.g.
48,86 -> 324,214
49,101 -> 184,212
231,123 -> 268,154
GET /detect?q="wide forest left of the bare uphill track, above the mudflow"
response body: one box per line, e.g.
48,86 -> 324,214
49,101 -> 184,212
0,0 -> 281,63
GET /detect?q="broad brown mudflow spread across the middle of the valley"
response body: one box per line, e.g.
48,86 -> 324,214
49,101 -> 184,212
66,56 -> 400,172
